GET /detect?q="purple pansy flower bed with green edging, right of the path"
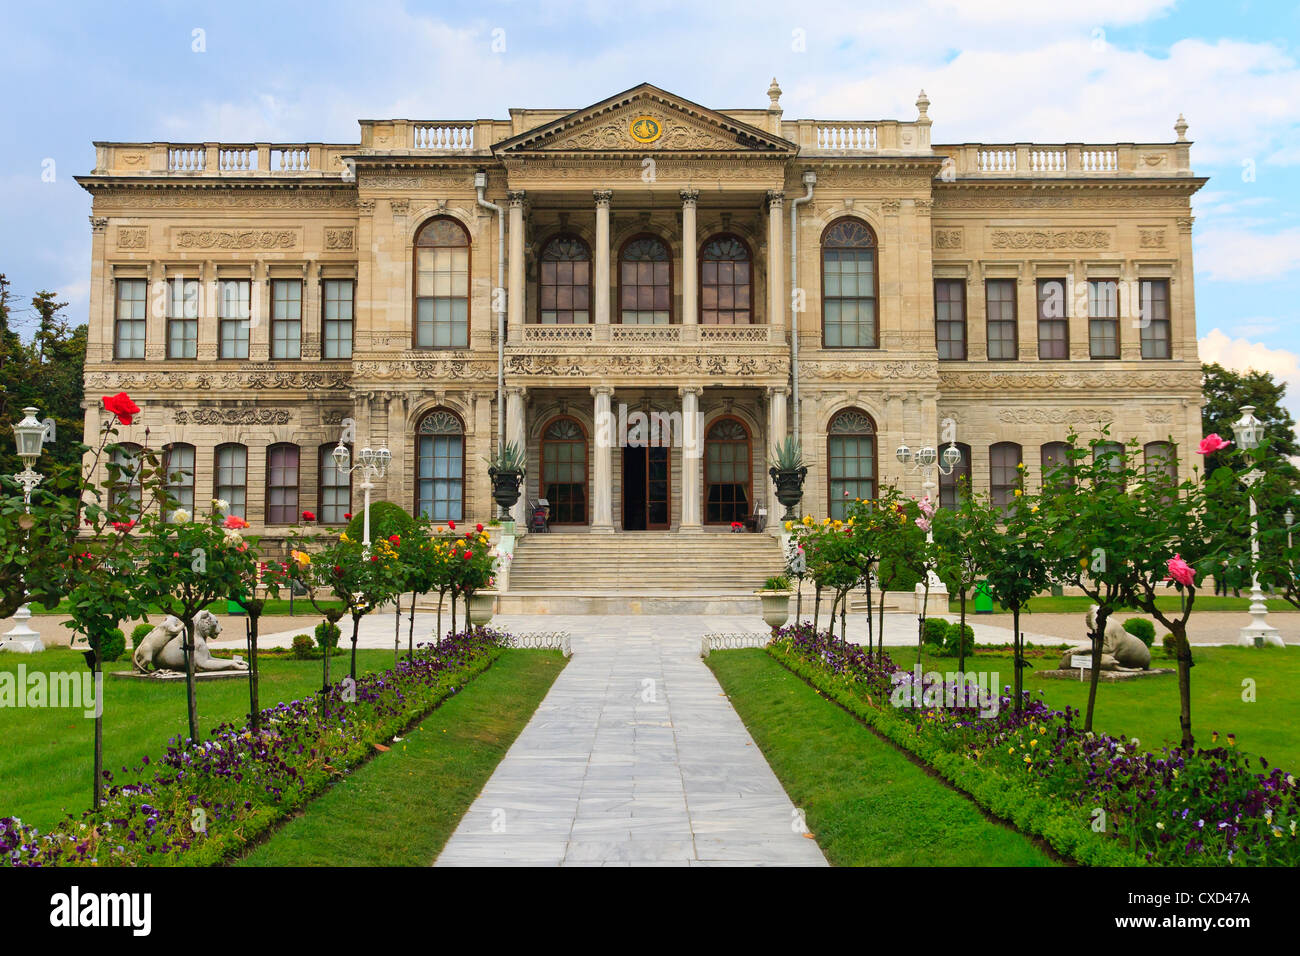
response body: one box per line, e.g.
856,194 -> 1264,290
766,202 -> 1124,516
768,623 -> 1300,866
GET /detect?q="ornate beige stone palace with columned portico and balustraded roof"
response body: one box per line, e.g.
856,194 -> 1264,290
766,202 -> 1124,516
78,81 -> 1205,598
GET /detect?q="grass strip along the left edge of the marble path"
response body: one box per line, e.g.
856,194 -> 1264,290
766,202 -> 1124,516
239,650 -> 564,866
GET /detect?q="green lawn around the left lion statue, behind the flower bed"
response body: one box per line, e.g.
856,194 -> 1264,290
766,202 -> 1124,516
0,648 -> 393,830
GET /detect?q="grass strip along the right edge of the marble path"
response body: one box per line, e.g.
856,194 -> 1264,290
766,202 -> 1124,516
709,650 -> 1053,866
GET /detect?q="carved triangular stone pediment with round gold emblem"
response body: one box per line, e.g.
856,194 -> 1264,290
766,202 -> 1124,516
493,83 -> 797,156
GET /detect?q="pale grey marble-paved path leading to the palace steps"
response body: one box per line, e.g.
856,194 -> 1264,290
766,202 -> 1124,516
437,617 -> 826,866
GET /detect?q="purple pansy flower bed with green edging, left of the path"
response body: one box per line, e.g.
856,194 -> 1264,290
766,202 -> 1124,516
0,627 -> 510,866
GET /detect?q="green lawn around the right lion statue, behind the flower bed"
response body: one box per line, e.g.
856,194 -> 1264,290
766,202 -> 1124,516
888,646 -> 1300,771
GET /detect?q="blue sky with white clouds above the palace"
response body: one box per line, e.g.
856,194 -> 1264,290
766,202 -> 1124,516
0,0 -> 1300,418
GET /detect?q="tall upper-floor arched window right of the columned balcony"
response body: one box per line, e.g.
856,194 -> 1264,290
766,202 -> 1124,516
822,219 -> 879,349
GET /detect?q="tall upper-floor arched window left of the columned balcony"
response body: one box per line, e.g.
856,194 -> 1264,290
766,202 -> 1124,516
413,217 -> 469,349
